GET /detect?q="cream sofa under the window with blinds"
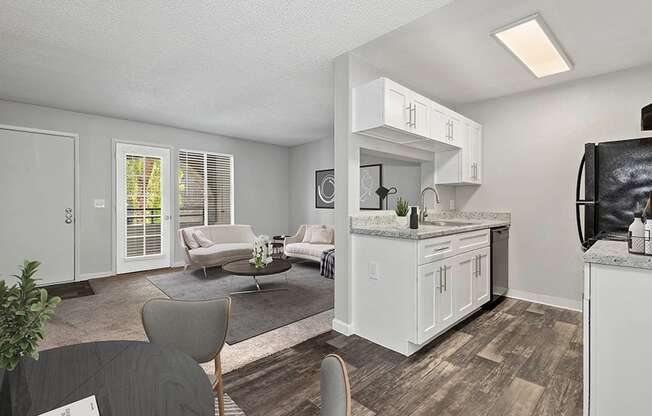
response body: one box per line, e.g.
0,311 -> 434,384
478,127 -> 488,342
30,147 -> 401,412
179,225 -> 256,277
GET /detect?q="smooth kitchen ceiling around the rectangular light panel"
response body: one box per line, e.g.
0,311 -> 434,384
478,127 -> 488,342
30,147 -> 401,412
354,0 -> 652,105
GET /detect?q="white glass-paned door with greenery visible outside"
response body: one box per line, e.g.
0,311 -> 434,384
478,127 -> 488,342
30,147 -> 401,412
116,143 -> 171,273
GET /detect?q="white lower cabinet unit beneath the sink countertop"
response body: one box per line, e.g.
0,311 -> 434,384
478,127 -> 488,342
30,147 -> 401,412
351,229 -> 490,356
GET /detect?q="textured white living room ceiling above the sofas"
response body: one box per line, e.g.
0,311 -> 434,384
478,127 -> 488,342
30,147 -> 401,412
0,0 -> 450,145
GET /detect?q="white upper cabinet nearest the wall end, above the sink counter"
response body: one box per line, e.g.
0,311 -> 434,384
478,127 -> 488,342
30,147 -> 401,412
353,78 -> 459,151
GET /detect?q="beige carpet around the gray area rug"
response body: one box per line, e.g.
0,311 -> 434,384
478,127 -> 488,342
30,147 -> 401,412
39,269 -> 333,376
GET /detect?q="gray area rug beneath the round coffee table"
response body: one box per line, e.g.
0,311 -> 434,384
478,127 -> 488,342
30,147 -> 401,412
148,262 -> 334,345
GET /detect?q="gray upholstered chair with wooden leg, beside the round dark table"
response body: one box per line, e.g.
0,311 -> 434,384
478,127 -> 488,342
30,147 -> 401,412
141,297 -> 231,416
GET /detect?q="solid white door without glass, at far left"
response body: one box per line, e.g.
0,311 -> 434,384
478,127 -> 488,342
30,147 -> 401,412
0,126 -> 76,285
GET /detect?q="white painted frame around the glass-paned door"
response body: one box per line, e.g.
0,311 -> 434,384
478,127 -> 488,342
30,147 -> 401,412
111,139 -> 177,274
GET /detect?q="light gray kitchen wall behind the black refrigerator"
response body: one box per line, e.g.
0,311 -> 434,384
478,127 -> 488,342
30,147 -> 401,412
456,66 -> 652,306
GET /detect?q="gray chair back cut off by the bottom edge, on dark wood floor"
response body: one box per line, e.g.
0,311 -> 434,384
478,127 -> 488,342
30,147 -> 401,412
319,354 -> 351,416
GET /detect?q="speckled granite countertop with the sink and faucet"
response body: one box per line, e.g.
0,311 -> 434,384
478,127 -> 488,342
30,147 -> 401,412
350,212 -> 511,240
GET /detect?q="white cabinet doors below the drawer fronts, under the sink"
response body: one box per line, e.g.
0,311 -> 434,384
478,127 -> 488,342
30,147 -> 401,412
417,247 -> 490,344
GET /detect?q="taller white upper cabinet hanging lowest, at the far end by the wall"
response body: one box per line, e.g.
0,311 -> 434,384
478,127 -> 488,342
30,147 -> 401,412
435,120 -> 482,185
